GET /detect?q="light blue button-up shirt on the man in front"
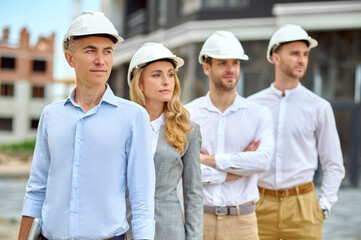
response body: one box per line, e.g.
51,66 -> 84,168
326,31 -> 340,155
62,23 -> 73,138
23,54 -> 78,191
22,86 -> 155,239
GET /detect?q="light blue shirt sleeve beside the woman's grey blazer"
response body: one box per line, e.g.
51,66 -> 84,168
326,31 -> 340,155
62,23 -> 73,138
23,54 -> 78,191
127,109 -> 155,239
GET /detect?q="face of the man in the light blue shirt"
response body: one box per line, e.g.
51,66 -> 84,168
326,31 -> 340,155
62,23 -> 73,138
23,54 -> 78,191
65,36 -> 114,87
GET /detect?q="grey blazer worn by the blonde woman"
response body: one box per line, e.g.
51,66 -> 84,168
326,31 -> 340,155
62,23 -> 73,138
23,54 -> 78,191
127,122 -> 203,240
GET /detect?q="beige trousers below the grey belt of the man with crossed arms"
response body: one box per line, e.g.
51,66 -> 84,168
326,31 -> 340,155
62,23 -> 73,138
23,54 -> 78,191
203,212 -> 259,240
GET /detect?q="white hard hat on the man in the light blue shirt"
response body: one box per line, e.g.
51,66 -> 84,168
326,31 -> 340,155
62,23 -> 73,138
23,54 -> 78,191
63,11 -> 124,51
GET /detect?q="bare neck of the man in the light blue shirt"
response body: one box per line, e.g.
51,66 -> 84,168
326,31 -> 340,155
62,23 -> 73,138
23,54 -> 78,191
74,85 -> 106,112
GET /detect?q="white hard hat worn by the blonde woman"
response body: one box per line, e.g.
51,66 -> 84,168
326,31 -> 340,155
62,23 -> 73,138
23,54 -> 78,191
128,42 -> 184,86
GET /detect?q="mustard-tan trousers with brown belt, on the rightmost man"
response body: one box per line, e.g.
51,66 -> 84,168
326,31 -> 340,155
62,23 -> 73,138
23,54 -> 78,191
256,188 -> 324,240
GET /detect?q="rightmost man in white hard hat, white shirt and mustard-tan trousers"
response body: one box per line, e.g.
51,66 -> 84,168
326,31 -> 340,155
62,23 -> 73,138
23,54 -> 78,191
249,24 -> 345,240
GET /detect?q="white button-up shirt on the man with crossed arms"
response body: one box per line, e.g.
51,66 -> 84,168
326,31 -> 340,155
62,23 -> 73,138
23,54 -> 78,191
186,93 -> 274,206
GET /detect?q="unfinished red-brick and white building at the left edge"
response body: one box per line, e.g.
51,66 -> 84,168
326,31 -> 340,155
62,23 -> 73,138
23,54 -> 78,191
0,28 -> 55,144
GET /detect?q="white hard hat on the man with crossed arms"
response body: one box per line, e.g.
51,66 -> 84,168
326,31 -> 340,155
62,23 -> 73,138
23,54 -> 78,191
198,31 -> 248,64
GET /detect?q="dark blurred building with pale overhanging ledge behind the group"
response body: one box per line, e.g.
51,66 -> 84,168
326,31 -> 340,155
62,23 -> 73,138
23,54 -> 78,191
102,0 -> 361,186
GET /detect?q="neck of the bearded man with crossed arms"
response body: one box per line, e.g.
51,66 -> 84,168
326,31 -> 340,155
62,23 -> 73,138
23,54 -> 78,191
209,88 -> 237,113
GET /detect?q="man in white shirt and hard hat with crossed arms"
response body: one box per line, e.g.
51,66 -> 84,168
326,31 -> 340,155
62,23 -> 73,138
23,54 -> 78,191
186,31 -> 274,240
